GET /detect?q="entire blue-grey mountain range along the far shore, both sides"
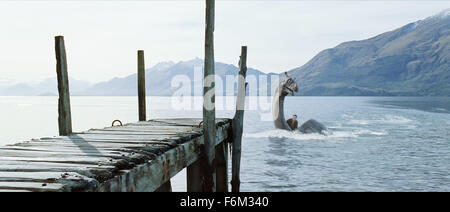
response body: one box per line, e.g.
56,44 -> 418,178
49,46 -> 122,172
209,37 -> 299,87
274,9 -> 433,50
0,9 -> 450,96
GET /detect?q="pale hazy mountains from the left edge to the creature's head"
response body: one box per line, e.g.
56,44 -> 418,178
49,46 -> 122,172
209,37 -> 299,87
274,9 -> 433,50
0,58 -> 276,96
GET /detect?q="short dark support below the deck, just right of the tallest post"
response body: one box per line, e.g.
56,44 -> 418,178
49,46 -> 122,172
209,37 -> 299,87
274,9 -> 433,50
216,141 -> 228,192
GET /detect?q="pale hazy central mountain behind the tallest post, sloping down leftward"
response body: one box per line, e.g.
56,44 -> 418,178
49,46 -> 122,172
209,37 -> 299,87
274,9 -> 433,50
74,58 -> 273,96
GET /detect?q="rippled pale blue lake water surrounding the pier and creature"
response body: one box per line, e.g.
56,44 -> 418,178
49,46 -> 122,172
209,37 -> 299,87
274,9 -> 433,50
0,97 -> 450,191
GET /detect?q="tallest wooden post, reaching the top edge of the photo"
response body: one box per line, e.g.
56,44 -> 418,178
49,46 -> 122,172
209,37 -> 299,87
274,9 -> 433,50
202,0 -> 216,192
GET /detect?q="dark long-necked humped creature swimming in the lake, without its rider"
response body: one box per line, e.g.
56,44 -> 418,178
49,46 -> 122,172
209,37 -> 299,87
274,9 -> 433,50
272,73 -> 326,134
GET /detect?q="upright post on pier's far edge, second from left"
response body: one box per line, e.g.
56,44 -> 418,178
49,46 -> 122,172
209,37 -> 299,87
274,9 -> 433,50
138,50 -> 147,121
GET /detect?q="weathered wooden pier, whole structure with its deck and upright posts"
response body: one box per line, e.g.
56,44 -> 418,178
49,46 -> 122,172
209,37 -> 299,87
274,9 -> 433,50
0,0 -> 247,192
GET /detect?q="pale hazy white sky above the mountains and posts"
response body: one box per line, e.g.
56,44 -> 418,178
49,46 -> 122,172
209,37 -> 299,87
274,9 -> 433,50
0,0 -> 450,82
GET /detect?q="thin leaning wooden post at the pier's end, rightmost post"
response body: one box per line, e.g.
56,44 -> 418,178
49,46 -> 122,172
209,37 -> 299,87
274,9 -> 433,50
231,46 -> 247,192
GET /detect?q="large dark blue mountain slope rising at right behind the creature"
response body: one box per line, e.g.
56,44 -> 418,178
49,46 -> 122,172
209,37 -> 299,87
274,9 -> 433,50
289,9 -> 450,96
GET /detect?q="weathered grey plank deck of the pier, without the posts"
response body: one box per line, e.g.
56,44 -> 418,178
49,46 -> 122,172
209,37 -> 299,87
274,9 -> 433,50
0,119 -> 232,192
